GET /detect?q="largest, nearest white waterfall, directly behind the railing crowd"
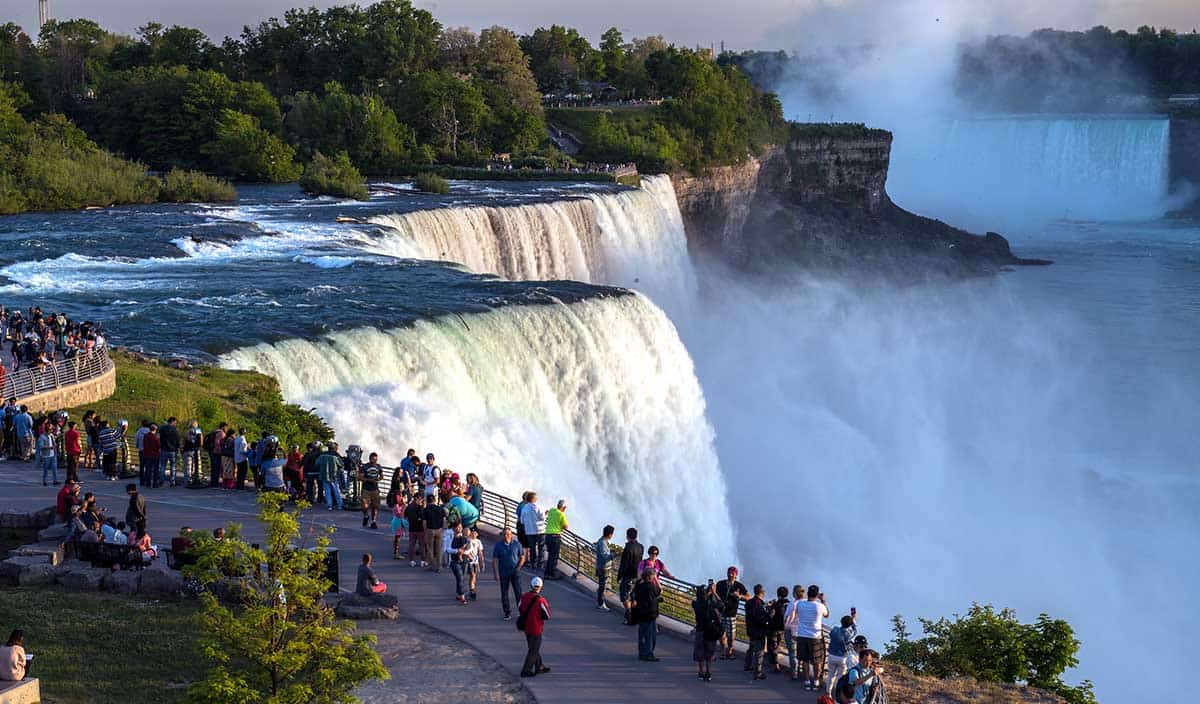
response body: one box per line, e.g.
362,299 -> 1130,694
221,294 -> 733,577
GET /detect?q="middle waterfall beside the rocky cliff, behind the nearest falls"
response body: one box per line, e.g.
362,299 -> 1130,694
365,176 -> 696,307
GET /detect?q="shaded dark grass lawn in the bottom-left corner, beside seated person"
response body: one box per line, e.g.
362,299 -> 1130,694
0,588 -> 205,704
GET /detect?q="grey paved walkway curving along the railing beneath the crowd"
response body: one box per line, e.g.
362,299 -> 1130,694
0,462 -> 816,704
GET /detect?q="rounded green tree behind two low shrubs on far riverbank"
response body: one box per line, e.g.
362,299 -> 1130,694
200,109 -> 302,183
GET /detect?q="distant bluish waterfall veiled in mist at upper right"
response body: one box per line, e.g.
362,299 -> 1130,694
888,115 -> 1170,230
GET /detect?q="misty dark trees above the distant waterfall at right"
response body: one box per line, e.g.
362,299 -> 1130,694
955,26 -> 1200,112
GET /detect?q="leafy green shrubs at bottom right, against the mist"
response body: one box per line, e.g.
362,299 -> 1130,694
884,603 -> 1096,704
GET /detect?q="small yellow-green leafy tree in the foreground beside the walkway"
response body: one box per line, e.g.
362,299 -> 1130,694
185,492 -> 389,704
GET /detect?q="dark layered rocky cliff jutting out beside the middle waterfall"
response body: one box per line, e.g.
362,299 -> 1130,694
673,125 -> 1033,278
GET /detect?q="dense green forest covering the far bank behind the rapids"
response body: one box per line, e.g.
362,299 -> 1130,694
0,0 -> 782,191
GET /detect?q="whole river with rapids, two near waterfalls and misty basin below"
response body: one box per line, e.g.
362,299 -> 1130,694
0,172 -> 1200,700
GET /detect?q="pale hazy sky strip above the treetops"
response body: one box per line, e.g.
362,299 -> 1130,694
0,0 -> 1200,49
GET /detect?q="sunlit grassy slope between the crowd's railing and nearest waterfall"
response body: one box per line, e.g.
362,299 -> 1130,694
68,350 -> 334,444
